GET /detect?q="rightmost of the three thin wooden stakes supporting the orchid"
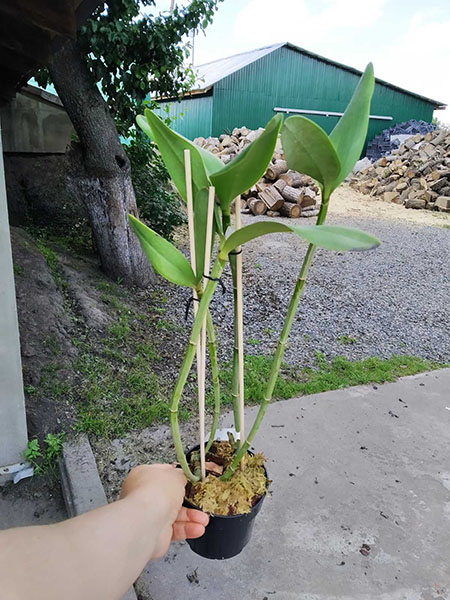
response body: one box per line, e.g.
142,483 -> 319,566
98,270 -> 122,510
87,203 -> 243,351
234,196 -> 245,446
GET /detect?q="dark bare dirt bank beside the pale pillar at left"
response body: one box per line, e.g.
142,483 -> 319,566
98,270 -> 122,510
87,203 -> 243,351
11,227 -> 77,437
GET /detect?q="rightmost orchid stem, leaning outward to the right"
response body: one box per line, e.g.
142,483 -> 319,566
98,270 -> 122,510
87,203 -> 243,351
221,196 -> 329,481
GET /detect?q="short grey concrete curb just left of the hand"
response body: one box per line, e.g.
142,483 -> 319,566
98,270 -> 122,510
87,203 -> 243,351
59,434 -> 137,600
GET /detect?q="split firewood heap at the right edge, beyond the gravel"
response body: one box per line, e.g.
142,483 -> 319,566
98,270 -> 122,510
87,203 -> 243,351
350,129 -> 450,212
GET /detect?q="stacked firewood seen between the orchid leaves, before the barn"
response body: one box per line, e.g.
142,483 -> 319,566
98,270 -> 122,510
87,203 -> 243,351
194,127 -> 320,218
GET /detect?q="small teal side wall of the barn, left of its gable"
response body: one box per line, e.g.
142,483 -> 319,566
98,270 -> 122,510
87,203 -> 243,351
155,96 -> 213,140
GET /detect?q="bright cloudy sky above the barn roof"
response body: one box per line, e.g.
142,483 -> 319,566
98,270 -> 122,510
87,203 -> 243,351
156,0 -> 450,124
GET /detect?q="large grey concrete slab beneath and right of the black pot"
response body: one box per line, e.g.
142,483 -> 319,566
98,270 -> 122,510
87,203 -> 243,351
137,369 -> 450,600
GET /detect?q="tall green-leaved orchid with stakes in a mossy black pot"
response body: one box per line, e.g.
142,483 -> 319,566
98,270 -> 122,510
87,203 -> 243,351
129,65 -> 379,558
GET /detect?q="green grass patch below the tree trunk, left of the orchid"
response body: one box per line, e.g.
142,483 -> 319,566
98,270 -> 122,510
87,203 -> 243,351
74,282 -> 188,438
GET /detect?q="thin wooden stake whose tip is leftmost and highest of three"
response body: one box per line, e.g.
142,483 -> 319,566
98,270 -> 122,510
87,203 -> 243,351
184,150 -> 206,479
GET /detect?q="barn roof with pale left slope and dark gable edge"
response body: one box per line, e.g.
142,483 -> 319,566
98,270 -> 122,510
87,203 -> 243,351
193,42 -> 447,109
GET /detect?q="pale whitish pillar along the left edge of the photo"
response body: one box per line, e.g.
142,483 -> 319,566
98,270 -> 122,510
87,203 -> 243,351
0,116 -> 28,484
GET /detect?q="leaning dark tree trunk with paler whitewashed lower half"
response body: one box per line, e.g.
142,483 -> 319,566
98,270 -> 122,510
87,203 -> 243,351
48,40 -> 154,287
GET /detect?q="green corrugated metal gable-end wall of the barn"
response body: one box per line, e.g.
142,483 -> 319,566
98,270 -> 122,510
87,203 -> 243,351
212,47 -> 433,146
